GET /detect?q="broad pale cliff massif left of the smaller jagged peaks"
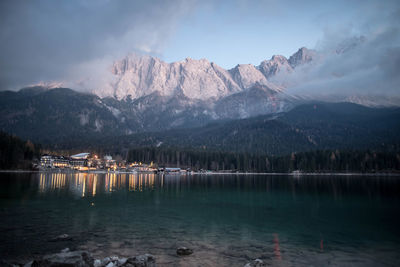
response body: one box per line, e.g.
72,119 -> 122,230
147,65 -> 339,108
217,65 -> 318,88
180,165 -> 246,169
105,54 -> 241,100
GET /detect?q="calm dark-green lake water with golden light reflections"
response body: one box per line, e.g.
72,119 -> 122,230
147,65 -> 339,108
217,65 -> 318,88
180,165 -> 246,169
0,173 -> 400,266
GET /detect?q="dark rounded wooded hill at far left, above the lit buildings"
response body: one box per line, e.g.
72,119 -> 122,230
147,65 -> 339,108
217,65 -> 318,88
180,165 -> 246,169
0,88 -> 129,143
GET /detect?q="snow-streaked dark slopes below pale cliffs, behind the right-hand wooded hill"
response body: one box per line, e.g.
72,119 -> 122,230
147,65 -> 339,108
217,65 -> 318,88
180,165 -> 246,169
0,85 -> 289,144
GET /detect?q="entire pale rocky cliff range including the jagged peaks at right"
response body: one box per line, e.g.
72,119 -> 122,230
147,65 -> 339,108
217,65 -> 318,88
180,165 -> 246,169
97,48 -> 311,101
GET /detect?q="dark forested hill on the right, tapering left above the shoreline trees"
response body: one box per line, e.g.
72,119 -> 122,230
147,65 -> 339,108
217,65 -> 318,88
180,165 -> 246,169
98,103 -> 400,155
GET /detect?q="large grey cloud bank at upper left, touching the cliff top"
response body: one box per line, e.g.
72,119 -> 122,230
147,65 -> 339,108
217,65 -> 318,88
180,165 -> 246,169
0,0 -> 196,90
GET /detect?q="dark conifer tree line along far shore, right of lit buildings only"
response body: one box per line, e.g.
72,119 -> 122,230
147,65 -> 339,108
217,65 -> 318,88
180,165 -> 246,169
127,147 -> 400,172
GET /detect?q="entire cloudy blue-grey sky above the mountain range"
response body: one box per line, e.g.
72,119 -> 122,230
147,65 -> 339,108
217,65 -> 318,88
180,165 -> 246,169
0,0 -> 400,93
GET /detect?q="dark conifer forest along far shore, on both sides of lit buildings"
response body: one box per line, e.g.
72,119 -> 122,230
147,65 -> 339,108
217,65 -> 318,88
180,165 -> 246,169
0,132 -> 400,173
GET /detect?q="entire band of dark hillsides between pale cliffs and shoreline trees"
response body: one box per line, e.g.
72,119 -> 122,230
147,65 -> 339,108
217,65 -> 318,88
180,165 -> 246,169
0,86 -> 400,155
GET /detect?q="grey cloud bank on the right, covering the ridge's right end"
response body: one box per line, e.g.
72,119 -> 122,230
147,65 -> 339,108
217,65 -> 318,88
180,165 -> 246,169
277,1 -> 400,97
